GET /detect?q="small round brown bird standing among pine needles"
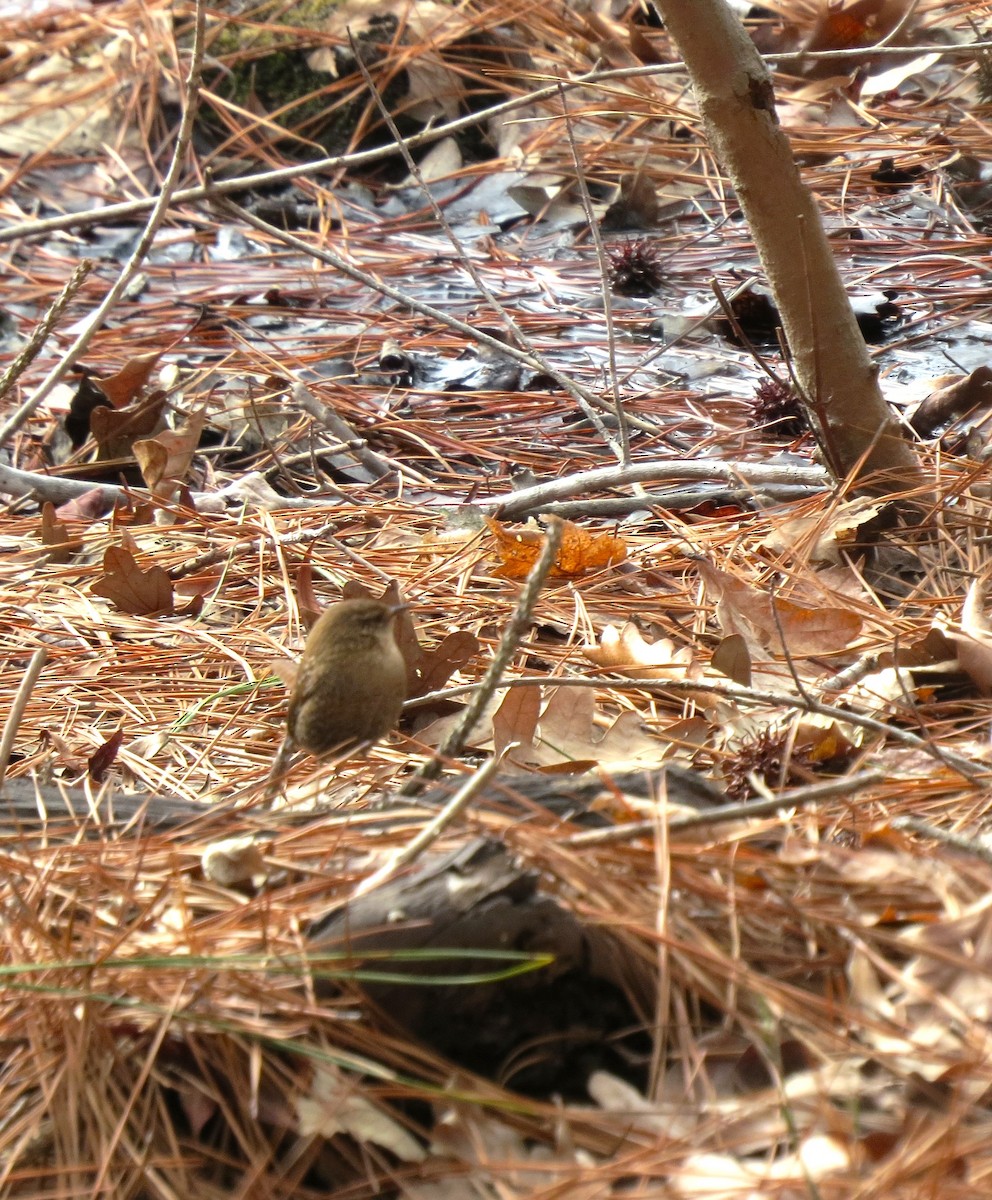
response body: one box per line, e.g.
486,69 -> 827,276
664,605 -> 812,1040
287,600 -> 407,754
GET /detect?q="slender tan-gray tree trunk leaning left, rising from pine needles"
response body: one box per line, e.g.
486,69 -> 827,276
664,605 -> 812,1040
655,0 -> 925,492
